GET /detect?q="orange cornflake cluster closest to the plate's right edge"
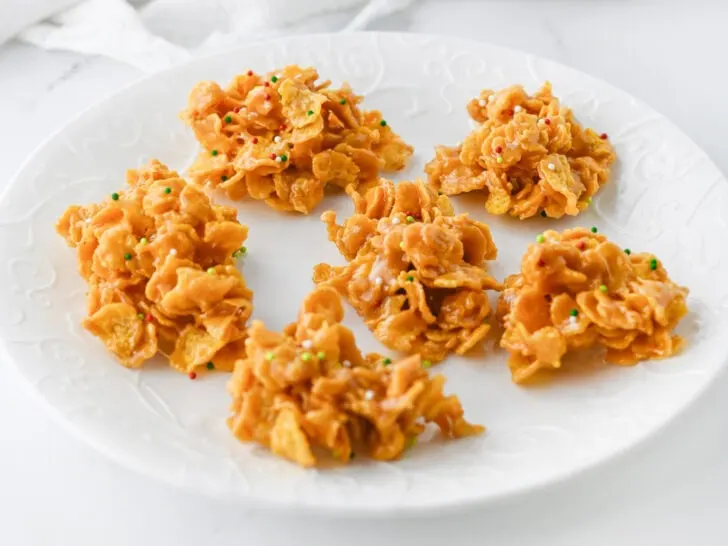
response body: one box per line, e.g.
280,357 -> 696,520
498,228 -> 688,383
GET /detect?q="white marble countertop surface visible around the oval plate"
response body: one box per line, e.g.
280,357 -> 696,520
0,0 -> 728,546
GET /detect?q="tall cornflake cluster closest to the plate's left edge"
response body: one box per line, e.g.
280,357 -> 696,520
56,161 -> 253,373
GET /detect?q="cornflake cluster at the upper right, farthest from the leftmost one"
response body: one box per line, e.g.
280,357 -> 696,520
425,82 -> 615,219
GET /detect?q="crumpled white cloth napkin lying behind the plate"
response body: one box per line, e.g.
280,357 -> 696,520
19,0 -> 415,72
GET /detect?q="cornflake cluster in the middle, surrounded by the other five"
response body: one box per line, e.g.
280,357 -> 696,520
314,179 -> 500,364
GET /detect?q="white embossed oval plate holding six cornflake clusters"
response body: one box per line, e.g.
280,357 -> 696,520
0,34 -> 728,515
